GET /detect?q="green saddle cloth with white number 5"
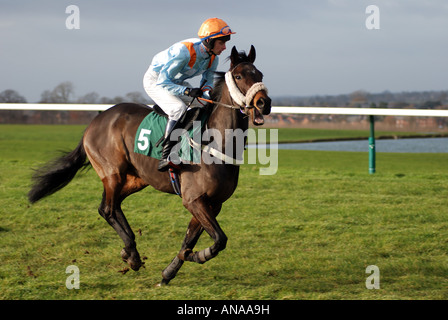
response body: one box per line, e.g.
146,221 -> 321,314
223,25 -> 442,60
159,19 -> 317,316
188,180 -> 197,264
134,110 -> 208,163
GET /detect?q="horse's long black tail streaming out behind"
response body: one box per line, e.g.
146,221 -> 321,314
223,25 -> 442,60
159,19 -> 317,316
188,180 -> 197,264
28,140 -> 90,203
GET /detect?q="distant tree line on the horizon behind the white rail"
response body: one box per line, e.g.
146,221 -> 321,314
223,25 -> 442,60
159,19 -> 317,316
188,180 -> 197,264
0,81 -> 448,128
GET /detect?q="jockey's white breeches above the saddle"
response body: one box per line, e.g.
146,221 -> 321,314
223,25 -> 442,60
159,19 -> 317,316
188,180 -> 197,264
143,71 -> 201,121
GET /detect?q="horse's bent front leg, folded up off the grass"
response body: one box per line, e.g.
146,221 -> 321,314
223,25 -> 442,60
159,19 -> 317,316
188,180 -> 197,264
178,194 -> 227,264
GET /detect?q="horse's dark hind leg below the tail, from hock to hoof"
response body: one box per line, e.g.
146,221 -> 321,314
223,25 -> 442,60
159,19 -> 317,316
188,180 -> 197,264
98,175 -> 142,271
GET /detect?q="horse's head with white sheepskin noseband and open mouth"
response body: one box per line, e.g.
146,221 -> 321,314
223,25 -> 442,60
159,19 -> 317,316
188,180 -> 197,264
226,46 -> 271,126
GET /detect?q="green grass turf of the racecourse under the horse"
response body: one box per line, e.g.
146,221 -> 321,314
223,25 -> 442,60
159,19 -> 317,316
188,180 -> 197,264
0,126 -> 448,300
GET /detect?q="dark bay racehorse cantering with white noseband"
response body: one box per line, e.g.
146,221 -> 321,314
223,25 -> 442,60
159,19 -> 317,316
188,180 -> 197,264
28,46 -> 271,284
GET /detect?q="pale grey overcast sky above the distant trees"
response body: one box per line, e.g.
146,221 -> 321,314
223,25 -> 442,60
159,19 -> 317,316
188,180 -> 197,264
0,0 -> 448,102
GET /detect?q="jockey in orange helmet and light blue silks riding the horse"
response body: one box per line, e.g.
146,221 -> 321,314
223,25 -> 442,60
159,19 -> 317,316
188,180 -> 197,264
143,18 -> 235,171
